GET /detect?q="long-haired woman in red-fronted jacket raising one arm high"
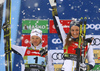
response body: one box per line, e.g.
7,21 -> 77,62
49,0 -> 95,71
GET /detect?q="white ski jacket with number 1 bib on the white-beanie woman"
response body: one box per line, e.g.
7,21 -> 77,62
12,44 -> 54,71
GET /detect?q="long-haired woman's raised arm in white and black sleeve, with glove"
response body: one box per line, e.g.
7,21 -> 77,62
49,0 -> 66,45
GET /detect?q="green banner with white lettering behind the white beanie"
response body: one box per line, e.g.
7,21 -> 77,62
22,19 -> 48,33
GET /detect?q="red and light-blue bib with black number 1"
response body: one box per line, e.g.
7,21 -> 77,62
23,48 -> 46,67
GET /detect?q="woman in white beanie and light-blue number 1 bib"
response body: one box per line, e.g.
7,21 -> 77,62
12,29 -> 54,71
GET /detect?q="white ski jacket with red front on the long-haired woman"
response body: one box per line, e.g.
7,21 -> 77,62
53,11 -> 95,66
